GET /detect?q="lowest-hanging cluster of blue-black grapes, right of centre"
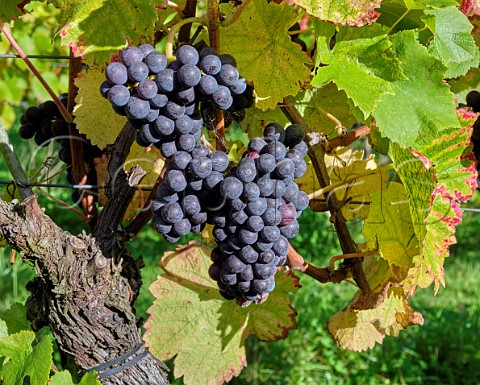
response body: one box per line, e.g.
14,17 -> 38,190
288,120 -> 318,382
209,123 -> 309,305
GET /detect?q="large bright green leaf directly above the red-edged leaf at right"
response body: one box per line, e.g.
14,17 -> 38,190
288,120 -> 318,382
373,31 -> 459,147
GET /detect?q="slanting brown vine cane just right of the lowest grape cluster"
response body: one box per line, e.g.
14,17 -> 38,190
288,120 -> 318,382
279,97 -> 371,293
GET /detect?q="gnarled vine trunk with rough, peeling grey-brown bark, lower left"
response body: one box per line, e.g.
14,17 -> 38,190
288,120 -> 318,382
0,121 -> 168,385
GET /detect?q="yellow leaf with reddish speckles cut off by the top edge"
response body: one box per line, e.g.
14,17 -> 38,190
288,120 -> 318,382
293,0 -> 382,27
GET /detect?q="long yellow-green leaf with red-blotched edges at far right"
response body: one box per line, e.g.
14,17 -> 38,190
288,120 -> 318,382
409,126 -> 477,290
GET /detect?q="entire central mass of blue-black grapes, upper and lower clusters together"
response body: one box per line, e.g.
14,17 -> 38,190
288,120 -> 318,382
100,44 -> 309,305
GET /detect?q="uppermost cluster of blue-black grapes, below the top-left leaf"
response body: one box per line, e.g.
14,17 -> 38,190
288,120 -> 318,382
100,44 -> 253,153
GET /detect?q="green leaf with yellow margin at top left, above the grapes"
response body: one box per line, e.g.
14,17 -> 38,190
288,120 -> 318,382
52,0 -> 157,65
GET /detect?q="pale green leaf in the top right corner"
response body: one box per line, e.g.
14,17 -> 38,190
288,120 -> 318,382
423,7 -> 480,78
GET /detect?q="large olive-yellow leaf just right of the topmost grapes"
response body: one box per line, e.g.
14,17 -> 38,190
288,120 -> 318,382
220,0 -> 311,110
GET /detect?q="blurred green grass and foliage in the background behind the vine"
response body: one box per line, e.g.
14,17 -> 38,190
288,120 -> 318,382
0,2 -> 480,385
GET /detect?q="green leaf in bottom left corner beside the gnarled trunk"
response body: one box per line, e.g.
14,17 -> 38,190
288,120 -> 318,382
0,331 -> 53,385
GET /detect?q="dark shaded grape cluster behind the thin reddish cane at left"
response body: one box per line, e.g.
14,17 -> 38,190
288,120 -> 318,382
18,93 -> 102,203
